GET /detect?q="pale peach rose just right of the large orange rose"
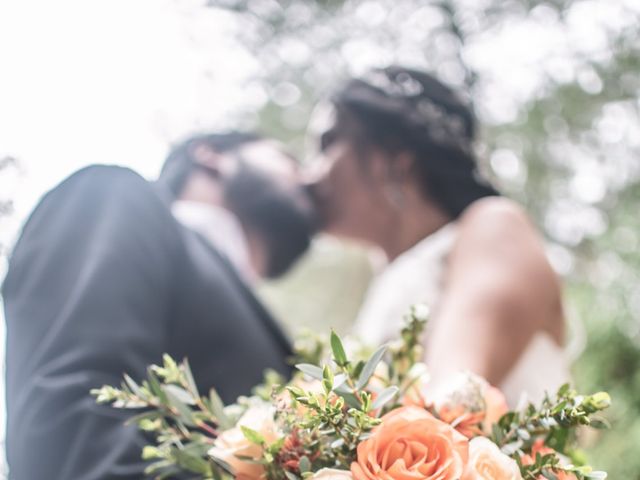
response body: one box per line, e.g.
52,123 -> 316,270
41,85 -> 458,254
462,437 -> 522,480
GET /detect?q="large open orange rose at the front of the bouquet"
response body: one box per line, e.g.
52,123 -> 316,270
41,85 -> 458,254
351,407 -> 468,480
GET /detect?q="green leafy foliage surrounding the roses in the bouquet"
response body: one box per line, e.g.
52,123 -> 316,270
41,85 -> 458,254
92,307 -> 611,480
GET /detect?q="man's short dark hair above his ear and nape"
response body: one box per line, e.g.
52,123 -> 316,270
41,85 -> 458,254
158,131 -> 262,197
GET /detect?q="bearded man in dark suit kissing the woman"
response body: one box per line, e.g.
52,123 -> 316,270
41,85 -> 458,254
3,133 -> 313,480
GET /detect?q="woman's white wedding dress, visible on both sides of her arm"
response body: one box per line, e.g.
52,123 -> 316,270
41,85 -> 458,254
354,223 -> 570,408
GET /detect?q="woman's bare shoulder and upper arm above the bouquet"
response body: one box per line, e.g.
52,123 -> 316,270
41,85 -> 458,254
427,198 -> 563,385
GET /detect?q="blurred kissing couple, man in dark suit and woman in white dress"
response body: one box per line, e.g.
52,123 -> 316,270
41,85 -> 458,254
3,66 -> 568,480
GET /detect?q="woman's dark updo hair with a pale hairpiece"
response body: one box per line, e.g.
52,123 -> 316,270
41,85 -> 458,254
331,66 -> 499,218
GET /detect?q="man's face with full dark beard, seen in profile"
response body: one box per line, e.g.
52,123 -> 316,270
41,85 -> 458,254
223,141 -> 315,277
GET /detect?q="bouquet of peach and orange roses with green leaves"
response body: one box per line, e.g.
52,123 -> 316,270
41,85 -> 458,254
92,305 -> 610,480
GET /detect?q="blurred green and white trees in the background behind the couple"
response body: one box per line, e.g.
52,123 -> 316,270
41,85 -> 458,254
209,0 -> 640,472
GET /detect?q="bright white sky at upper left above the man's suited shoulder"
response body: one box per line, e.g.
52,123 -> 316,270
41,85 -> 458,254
0,0 -> 264,240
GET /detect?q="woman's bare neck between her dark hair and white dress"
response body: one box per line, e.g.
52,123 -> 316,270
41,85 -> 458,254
380,202 -> 452,262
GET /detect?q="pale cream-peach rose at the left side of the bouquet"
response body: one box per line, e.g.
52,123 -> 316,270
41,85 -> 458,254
209,404 -> 278,480
